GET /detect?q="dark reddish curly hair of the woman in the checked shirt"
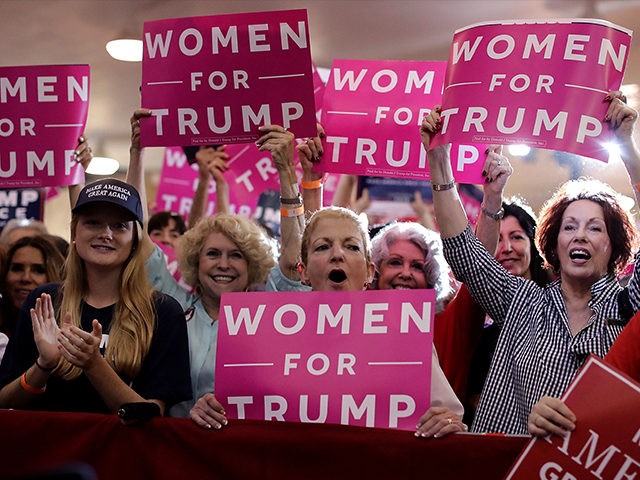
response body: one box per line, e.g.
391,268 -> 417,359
536,177 -> 638,274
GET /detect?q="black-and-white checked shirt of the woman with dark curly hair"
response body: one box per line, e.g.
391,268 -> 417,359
443,227 -> 640,434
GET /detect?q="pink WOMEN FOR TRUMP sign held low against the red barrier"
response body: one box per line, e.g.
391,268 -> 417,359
215,290 -> 434,430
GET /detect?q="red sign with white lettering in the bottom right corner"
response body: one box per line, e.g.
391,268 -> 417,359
505,356 -> 640,480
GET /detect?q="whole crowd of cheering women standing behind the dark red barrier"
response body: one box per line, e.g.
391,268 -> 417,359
0,92 -> 640,438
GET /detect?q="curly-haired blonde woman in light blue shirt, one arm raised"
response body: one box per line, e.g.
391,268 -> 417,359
127,108 -> 275,429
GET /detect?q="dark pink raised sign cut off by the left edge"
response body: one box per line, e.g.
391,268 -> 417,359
0,65 -> 89,188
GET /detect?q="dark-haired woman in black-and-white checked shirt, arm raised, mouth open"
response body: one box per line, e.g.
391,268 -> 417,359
421,93 -> 640,434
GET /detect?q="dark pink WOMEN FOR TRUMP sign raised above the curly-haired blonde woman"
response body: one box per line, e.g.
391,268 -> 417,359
141,10 -> 316,146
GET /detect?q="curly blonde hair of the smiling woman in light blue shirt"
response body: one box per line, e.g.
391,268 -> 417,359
176,213 -> 276,292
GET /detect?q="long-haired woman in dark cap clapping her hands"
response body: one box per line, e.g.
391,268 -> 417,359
0,179 -> 191,413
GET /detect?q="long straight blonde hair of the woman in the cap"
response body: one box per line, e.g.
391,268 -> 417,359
56,214 -> 156,380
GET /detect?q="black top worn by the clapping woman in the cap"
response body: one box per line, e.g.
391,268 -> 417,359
0,284 -> 191,413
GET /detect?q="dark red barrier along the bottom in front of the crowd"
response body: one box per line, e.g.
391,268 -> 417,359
0,410 -> 527,480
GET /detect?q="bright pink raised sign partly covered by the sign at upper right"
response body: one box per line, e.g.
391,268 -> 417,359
322,60 -> 486,183
